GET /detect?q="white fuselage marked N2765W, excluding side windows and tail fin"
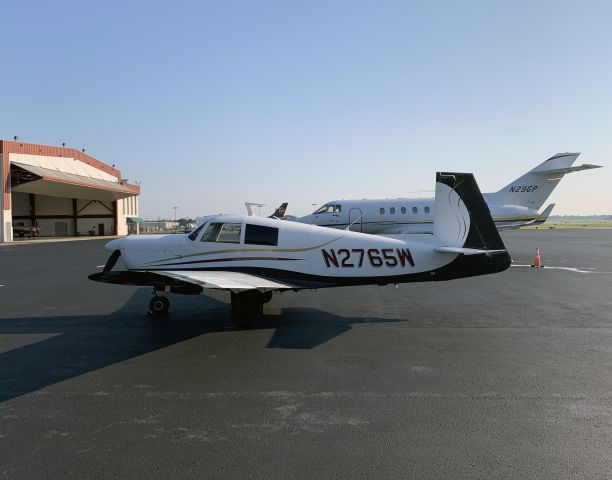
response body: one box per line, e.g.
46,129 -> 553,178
106,215 -> 457,286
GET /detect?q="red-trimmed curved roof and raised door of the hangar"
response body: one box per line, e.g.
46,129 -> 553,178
0,140 -> 140,205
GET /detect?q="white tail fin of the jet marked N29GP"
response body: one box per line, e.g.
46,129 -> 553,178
485,153 -> 600,210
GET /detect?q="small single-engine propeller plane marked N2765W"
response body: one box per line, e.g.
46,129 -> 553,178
89,173 -> 511,328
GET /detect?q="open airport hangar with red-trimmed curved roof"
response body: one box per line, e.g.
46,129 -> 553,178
0,138 -> 142,242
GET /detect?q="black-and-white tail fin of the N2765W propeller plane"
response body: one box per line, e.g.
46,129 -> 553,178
433,172 -> 511,280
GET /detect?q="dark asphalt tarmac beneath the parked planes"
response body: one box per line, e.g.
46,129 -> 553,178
0,230 -> 612,479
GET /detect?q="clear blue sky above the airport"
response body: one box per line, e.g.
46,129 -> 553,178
0,0 -> 612,218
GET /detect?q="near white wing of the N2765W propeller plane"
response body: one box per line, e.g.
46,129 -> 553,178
155,270 -> 296,293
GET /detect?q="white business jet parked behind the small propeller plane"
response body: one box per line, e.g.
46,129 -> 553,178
297,153 -> 600,234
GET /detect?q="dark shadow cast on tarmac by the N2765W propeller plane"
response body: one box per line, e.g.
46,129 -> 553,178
0,289 -> 403,402
